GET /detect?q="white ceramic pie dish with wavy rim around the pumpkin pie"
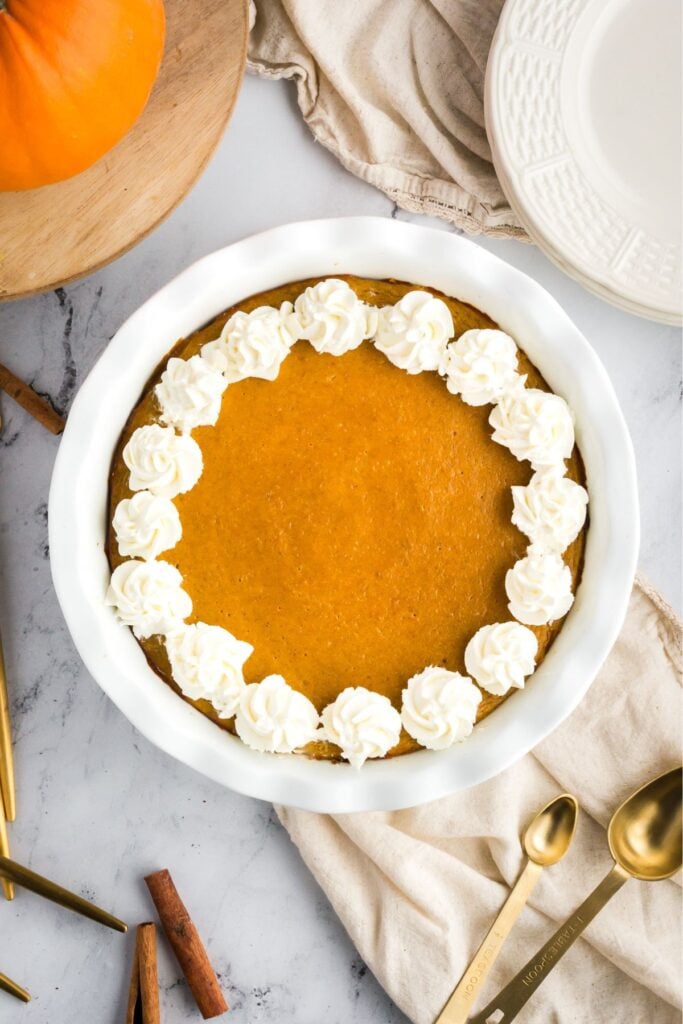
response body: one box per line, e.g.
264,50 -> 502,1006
49,217 -> 638,812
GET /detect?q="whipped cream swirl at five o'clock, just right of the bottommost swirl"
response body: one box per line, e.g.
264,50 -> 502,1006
400,666 -> 481,751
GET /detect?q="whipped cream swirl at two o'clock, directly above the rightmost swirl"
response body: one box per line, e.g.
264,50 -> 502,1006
488,387 -> 573,469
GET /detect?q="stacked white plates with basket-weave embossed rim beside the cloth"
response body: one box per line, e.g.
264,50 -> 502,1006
485,0 -> 683,324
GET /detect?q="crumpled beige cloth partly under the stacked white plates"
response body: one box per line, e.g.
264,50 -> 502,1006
247,0 -> 524,237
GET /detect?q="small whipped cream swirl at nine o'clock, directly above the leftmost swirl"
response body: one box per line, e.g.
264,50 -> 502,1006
113,490 -> 182,560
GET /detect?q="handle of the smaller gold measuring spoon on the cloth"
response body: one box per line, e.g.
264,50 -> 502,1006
434,860 -> 543,1024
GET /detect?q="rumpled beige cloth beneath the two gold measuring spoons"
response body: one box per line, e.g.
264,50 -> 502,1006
278,582 -> 682,1024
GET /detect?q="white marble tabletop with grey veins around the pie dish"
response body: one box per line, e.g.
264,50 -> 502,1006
0,79 -> 681,1024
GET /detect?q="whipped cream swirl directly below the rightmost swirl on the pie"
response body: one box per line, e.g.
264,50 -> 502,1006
505,547 -> 573,626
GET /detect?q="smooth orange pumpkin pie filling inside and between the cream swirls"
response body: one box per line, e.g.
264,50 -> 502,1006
108,276 -> 585,758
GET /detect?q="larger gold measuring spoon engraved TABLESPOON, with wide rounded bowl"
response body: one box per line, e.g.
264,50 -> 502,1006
471,768 -> 683,1024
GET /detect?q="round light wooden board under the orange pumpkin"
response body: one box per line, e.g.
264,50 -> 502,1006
0,0 -> 249,300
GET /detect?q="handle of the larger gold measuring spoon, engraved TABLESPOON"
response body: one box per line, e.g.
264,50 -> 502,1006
470,864 -> 631,1024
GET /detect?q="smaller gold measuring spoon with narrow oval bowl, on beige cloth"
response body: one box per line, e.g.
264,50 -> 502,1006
434,793 -> 579,1024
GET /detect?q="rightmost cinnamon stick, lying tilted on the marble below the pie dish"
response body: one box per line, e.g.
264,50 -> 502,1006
144,868 -> 228,1020
